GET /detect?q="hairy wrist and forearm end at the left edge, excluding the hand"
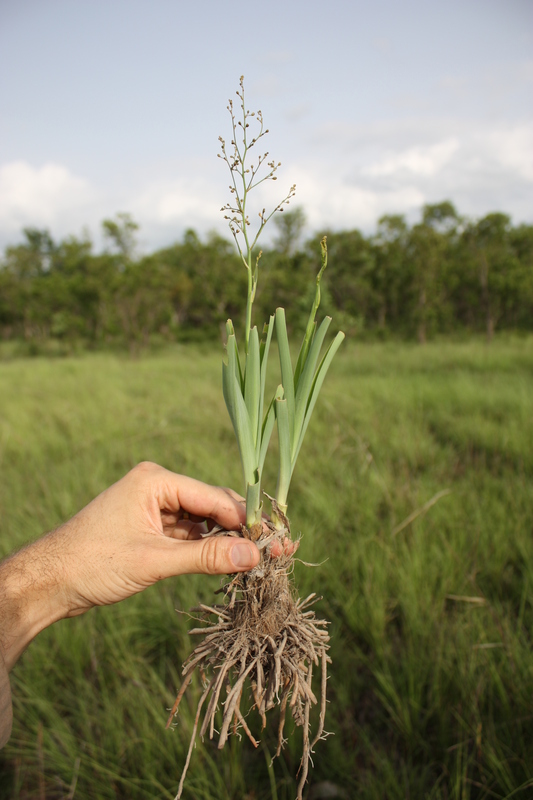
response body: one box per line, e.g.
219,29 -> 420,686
0,534 -> 68,672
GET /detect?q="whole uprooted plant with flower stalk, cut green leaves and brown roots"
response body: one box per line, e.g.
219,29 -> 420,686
167,78 -> 344,800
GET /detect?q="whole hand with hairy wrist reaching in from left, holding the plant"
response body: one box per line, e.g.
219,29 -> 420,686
0,462 -> 259,668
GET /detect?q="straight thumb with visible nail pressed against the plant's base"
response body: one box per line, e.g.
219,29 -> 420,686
156,536 -> 260,578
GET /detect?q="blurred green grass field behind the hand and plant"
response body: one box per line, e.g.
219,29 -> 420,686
0,338 -> 533,800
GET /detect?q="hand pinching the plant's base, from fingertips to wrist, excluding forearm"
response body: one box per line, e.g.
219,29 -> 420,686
54,462 -> 268,616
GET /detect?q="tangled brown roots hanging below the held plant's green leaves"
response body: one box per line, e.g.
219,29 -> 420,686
167,518 -> 331,800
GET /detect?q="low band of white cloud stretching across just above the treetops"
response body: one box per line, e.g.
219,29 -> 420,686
0,119 -> 533,251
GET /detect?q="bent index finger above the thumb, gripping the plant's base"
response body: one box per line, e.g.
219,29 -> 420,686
157,467 -> 246,530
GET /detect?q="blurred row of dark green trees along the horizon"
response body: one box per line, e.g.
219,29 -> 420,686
0,201 -> 533,352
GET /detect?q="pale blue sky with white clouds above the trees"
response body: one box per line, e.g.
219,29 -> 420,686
0,0 -> 533,252
